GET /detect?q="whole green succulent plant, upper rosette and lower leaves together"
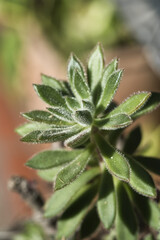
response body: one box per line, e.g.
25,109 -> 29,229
17,45 -> 160,240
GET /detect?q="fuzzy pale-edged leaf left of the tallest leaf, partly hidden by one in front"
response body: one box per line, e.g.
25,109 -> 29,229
68,54 -> 85,90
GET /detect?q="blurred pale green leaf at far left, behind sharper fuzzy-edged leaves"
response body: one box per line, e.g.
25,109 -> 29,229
16,123 -> 51,137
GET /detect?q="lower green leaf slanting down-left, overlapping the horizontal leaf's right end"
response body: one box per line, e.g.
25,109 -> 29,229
55,149 -> 91,190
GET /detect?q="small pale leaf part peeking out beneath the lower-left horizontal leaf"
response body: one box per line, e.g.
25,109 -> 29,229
37,166 -> 62,182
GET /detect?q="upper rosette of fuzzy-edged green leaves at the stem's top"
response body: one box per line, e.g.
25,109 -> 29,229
18,45 -> 150,148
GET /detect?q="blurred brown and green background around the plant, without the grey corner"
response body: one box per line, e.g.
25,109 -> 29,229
0,0 -> 160,232
